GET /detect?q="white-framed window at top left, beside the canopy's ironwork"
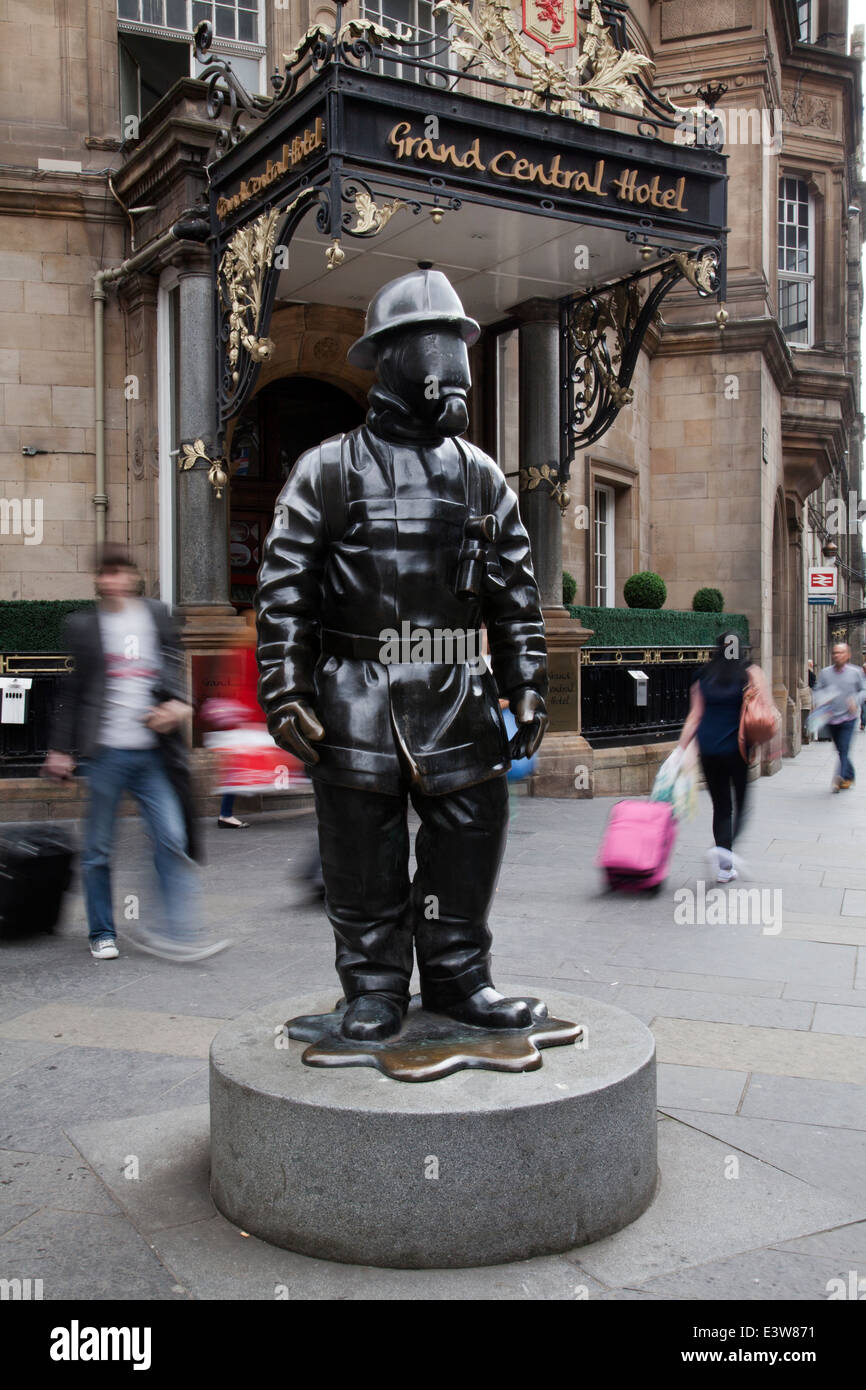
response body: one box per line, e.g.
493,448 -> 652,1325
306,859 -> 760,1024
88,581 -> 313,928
117,0 -> 265,131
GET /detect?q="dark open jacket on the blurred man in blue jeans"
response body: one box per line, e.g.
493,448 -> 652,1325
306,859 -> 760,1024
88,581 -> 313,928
49,599 -> 200,859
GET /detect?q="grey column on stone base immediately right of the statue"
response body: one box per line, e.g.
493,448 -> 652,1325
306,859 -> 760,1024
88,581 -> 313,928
512,299 -> 592,798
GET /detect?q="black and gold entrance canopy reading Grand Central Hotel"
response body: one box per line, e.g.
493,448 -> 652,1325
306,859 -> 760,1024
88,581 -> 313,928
196,0 -> 726,482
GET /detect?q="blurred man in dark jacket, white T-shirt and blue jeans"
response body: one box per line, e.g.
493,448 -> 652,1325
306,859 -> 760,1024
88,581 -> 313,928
42,546 -> 228,960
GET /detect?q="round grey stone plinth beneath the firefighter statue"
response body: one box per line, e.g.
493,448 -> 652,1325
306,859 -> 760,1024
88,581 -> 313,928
210,990 -> 656,1269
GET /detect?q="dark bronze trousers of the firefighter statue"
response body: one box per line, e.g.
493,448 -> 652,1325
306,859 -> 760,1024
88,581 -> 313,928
313,777 -> 509,1009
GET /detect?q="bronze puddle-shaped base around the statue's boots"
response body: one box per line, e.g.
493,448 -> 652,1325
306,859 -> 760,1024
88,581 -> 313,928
284,995 -> 584,1081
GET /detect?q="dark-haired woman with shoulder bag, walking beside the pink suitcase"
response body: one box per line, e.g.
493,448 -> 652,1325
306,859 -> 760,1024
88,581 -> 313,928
677,632 -> 778,883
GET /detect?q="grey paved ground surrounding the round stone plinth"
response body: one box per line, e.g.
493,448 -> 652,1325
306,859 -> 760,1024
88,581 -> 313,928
0,735 -> 866,1301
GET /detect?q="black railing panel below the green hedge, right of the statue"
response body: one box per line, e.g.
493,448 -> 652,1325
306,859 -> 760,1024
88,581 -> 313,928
581,648 -> 706,748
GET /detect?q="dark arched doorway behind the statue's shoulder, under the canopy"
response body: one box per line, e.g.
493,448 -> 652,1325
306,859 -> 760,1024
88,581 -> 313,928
229,377 -> 364,609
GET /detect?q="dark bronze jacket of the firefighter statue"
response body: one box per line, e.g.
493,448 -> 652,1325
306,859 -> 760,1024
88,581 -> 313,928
256,425 -> 548,794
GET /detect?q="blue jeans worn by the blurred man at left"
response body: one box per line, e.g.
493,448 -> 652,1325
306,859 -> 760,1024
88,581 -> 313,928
81,748 -> 200,942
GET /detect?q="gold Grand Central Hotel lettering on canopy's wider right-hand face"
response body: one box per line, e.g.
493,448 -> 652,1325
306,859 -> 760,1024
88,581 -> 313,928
388,121 -> 688,213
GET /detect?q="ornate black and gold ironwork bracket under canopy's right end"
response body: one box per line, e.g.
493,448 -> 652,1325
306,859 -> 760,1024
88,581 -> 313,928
557,246 -> 721,469
